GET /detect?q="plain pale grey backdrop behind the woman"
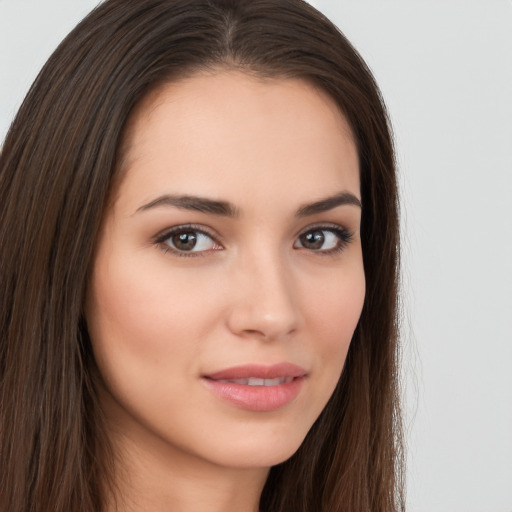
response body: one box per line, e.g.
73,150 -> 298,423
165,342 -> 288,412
0,0 -> 512,512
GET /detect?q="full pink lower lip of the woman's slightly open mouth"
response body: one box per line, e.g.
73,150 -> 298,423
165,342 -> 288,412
203,377 -> 305,412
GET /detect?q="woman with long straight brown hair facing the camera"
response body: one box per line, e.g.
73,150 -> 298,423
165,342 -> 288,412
0,0 -> 403,512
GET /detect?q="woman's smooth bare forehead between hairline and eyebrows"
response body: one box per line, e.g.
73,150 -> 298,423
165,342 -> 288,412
115,71 -> 359,212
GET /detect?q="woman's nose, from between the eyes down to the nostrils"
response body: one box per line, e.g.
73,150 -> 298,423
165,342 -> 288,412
227,248 -> 301,341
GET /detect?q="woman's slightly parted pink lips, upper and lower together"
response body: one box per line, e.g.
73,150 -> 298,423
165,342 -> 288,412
203,363 -> 307,412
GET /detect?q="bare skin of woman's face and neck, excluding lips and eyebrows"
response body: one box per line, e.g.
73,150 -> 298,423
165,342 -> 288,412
85,70 -> 365,512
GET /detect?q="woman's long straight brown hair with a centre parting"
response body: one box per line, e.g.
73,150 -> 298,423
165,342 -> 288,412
0,0 -> 404,512
